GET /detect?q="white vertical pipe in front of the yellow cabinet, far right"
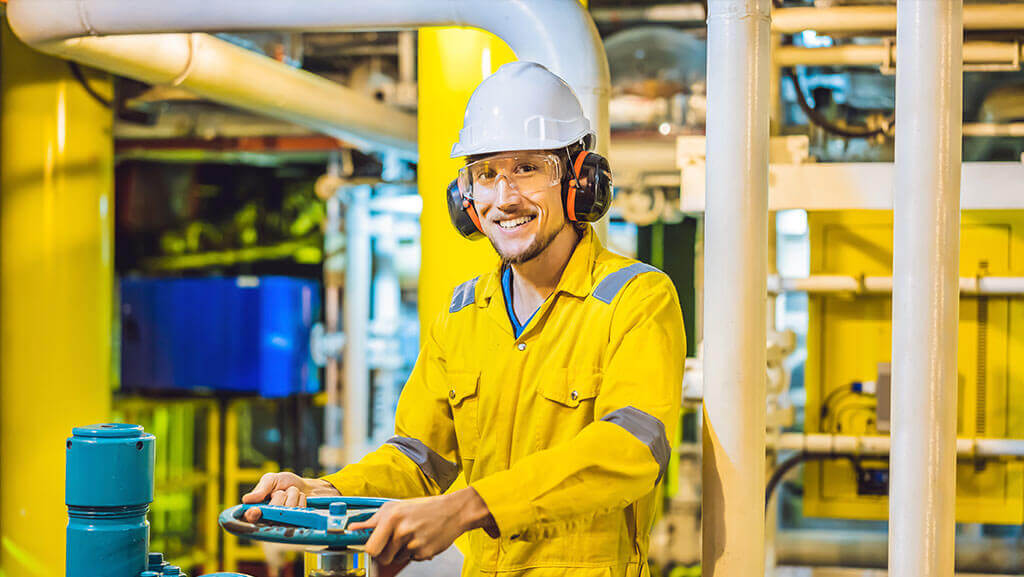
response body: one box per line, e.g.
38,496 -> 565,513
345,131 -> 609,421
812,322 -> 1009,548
889,0 -> 964,577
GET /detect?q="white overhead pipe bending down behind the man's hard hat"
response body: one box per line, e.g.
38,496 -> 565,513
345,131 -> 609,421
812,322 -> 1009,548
7,0 -> 610,154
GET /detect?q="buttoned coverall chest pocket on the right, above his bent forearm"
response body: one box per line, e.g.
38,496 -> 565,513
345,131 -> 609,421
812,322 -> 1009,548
534,369 -> 601,450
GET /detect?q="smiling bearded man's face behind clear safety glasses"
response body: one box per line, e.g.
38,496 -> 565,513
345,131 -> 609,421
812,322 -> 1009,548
474,151 -> 568,264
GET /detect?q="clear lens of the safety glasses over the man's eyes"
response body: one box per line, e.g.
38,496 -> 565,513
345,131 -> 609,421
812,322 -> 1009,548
459,153 -> 562,202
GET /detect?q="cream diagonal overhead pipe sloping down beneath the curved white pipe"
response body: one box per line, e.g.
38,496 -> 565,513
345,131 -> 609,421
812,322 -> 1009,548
7,33 -> 417,159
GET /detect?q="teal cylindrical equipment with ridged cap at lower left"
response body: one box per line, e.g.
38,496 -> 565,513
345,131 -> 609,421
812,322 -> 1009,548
65,423 -> 156,577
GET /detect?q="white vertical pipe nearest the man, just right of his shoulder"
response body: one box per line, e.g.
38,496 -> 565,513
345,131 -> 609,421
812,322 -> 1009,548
701,0 -> 771,577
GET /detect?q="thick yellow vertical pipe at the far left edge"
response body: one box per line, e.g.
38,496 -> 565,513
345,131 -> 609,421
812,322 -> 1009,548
0,20 -> 114,577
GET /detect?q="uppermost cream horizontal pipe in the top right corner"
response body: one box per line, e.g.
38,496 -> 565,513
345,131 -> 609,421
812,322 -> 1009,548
772,3 -> 1024,34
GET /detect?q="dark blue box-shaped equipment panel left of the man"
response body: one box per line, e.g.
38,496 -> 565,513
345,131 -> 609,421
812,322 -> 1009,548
121,277 -> 321,398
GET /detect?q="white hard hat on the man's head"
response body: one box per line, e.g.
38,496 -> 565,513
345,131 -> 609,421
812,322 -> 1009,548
452,61 -> 595,158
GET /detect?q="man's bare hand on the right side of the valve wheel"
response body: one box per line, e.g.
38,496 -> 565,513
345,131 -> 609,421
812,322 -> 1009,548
348,487 -> 497,566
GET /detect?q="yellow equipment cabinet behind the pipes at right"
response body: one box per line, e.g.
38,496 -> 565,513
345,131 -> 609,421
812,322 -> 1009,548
804,211 -> 1024,525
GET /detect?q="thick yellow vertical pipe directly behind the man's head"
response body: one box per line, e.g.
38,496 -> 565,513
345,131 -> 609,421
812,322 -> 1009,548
418,0 -> 587,334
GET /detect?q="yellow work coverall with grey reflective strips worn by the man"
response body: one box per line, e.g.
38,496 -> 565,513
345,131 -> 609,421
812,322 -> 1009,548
325,226 -> 686,577
